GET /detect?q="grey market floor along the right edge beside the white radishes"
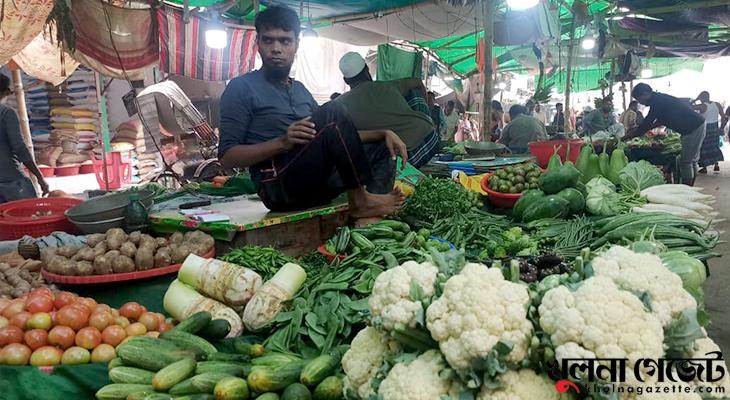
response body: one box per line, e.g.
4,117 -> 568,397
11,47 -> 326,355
696,156 -> 730,354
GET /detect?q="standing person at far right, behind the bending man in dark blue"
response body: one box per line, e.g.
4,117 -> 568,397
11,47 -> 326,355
692,91 -> 725,174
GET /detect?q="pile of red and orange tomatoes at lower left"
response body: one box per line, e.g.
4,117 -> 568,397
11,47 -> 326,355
0,288 -> 173,366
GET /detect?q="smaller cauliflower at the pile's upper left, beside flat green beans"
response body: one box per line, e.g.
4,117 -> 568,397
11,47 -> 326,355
368,261 -> 438,330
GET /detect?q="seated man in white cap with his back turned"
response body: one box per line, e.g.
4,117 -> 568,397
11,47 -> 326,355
335,52 -> 438,168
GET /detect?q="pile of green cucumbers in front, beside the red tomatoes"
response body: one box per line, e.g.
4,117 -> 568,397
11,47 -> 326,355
96,311 -> 343,400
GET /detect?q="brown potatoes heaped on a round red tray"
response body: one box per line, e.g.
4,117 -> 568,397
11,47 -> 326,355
41,228 -> 215,276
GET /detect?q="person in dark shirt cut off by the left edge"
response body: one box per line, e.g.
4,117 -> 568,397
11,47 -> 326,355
0,75 -> 48,203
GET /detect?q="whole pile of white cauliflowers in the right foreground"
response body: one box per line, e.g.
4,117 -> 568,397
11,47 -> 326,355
342,246 -> 730,400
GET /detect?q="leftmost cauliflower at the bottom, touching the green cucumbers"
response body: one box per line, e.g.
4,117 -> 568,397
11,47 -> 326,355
342,327 -> 398,399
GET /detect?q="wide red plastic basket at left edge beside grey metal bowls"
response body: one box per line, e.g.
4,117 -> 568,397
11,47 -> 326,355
0,197 -> 81,240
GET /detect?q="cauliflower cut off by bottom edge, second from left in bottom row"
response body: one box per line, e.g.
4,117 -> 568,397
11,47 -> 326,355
378,350 -> 461,400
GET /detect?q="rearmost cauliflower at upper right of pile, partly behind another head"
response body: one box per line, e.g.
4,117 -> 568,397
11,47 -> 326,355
592,246 -> 697,327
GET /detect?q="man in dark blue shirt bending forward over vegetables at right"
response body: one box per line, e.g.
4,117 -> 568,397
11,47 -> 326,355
623,83 -> 705,186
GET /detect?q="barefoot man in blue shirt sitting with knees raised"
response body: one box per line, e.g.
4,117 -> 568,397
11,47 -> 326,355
218,6 -> 408,223
